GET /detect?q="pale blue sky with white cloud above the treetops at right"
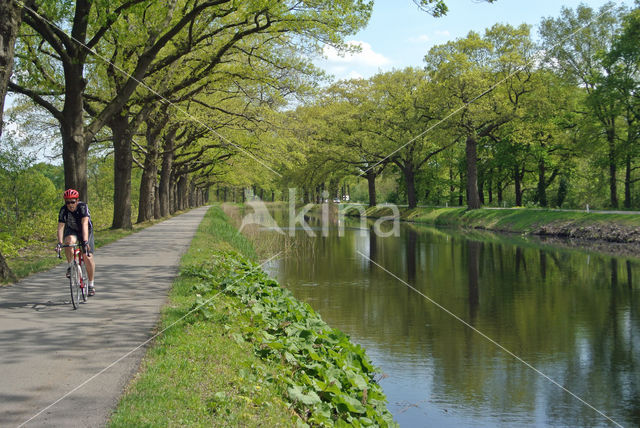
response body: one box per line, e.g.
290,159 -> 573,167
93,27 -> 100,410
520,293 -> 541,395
316,0 -> 633,79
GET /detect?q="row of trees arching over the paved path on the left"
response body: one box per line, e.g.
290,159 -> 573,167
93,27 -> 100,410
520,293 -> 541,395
0,0 -> 384,277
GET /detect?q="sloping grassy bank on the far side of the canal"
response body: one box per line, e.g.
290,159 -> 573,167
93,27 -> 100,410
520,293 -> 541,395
344,207 -> 640,242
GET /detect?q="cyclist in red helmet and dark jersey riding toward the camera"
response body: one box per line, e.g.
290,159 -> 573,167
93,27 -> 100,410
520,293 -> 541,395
58,189 -> 96,296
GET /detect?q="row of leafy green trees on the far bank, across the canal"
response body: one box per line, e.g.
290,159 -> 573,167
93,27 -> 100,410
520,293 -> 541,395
282,3 -> 640,208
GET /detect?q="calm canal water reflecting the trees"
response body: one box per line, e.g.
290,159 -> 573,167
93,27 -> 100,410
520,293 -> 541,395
262,211 -> 640,427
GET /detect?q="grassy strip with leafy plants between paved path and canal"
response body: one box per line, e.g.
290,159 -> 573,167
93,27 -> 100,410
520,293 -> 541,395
110,207 -> 400,427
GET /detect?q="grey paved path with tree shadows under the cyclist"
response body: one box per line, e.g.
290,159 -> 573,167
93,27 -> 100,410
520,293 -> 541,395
0,207 -> 207,427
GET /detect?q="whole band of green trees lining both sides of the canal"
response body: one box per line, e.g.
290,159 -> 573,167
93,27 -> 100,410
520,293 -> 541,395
0,0 -> 640,280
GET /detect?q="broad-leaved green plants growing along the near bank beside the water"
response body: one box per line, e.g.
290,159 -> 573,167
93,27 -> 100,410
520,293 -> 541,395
182,253 -> 395,426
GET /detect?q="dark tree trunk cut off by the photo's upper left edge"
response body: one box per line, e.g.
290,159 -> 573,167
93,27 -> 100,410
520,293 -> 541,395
0,0 -> 22,138
